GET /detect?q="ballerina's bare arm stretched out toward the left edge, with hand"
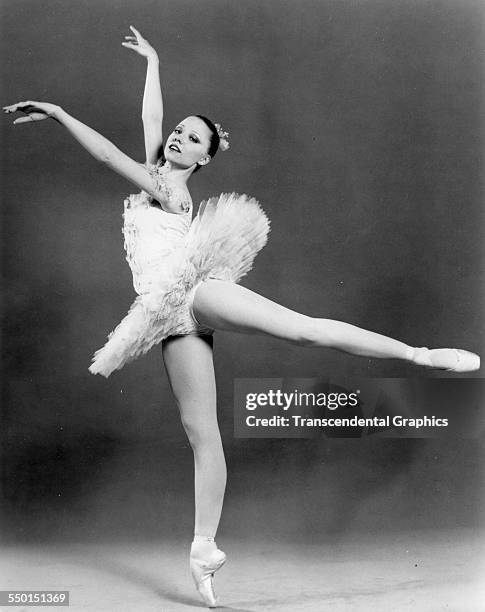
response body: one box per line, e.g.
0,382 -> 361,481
4,100 -> 182,213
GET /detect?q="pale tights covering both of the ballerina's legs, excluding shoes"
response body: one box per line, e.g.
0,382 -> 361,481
163,280 -> 449,546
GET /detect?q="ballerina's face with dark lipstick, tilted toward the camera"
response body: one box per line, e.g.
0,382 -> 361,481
163,117 -> 212,168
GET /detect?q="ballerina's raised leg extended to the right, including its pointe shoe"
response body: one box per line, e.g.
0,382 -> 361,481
193,280 -> 480,371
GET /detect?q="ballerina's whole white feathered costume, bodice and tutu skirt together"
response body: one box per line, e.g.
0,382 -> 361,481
89,161 -> 269,376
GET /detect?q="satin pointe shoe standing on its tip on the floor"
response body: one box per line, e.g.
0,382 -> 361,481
190,536 -> 226,608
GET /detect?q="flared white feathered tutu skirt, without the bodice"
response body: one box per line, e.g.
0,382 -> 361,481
89,193 -> 269,378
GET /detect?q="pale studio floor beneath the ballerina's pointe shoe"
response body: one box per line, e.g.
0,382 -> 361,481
0,529 -> 485,612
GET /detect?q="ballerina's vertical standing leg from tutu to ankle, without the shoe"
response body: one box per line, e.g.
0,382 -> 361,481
163,336 -> 226,537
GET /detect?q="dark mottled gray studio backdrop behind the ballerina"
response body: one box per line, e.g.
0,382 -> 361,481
1,0 -> 484,540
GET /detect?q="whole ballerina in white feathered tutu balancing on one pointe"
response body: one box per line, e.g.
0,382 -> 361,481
4,27 -> 480,607
